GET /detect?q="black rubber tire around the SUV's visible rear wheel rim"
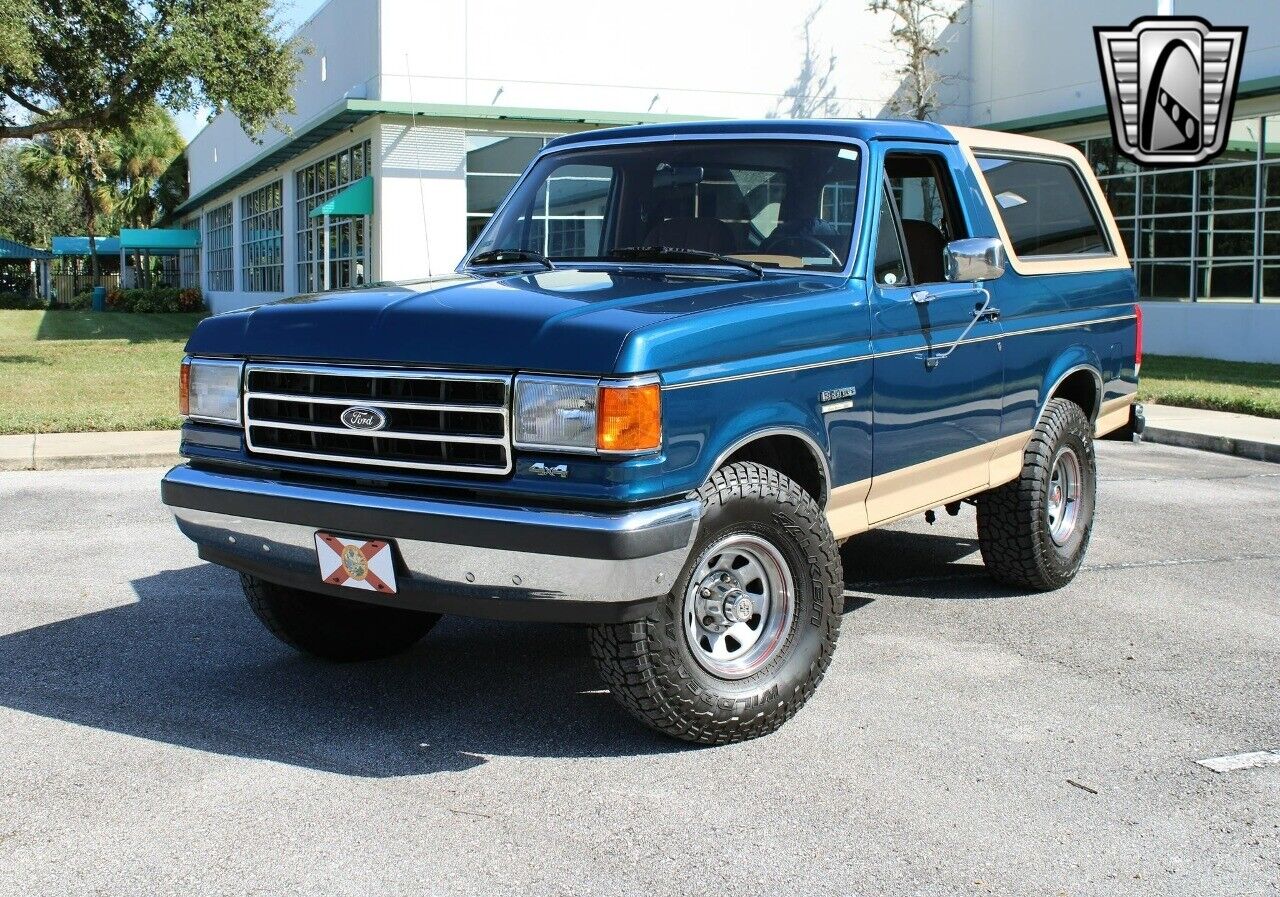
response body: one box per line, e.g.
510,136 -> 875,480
978,399 -> 1097,591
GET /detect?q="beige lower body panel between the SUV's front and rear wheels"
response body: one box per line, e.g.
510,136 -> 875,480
827,430 -> 1032,539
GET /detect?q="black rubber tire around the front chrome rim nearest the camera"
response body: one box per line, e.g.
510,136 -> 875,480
590,462 -> 845,745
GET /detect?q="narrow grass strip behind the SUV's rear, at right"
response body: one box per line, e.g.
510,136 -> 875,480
1138,354 -> 1280,417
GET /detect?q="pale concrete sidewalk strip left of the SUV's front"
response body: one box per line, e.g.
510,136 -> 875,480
0,430 -> 182,471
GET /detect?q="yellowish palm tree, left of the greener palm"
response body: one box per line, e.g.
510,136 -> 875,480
18,131 -> 119,285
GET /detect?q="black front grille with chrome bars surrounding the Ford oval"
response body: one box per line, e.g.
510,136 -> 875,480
244,365 -> 512,475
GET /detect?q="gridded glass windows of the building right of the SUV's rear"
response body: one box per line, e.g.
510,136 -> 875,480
1074,115 -> 1280,302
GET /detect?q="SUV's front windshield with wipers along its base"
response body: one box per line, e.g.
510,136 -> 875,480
470,139 -> 860,271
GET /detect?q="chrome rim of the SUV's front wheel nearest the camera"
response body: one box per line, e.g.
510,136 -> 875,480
684,534 -> 795,679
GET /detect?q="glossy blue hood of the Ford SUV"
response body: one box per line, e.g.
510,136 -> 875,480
187,269 -> 805,374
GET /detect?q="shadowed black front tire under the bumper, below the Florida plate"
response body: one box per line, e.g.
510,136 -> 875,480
241,573 -> 440,662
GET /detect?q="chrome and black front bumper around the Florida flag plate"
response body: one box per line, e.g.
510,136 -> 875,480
161,466 -> 701,622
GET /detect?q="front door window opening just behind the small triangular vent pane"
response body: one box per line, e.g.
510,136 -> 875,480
884,152 -> 966,283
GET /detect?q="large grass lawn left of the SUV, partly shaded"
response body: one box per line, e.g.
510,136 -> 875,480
0,310 -> 202,434
